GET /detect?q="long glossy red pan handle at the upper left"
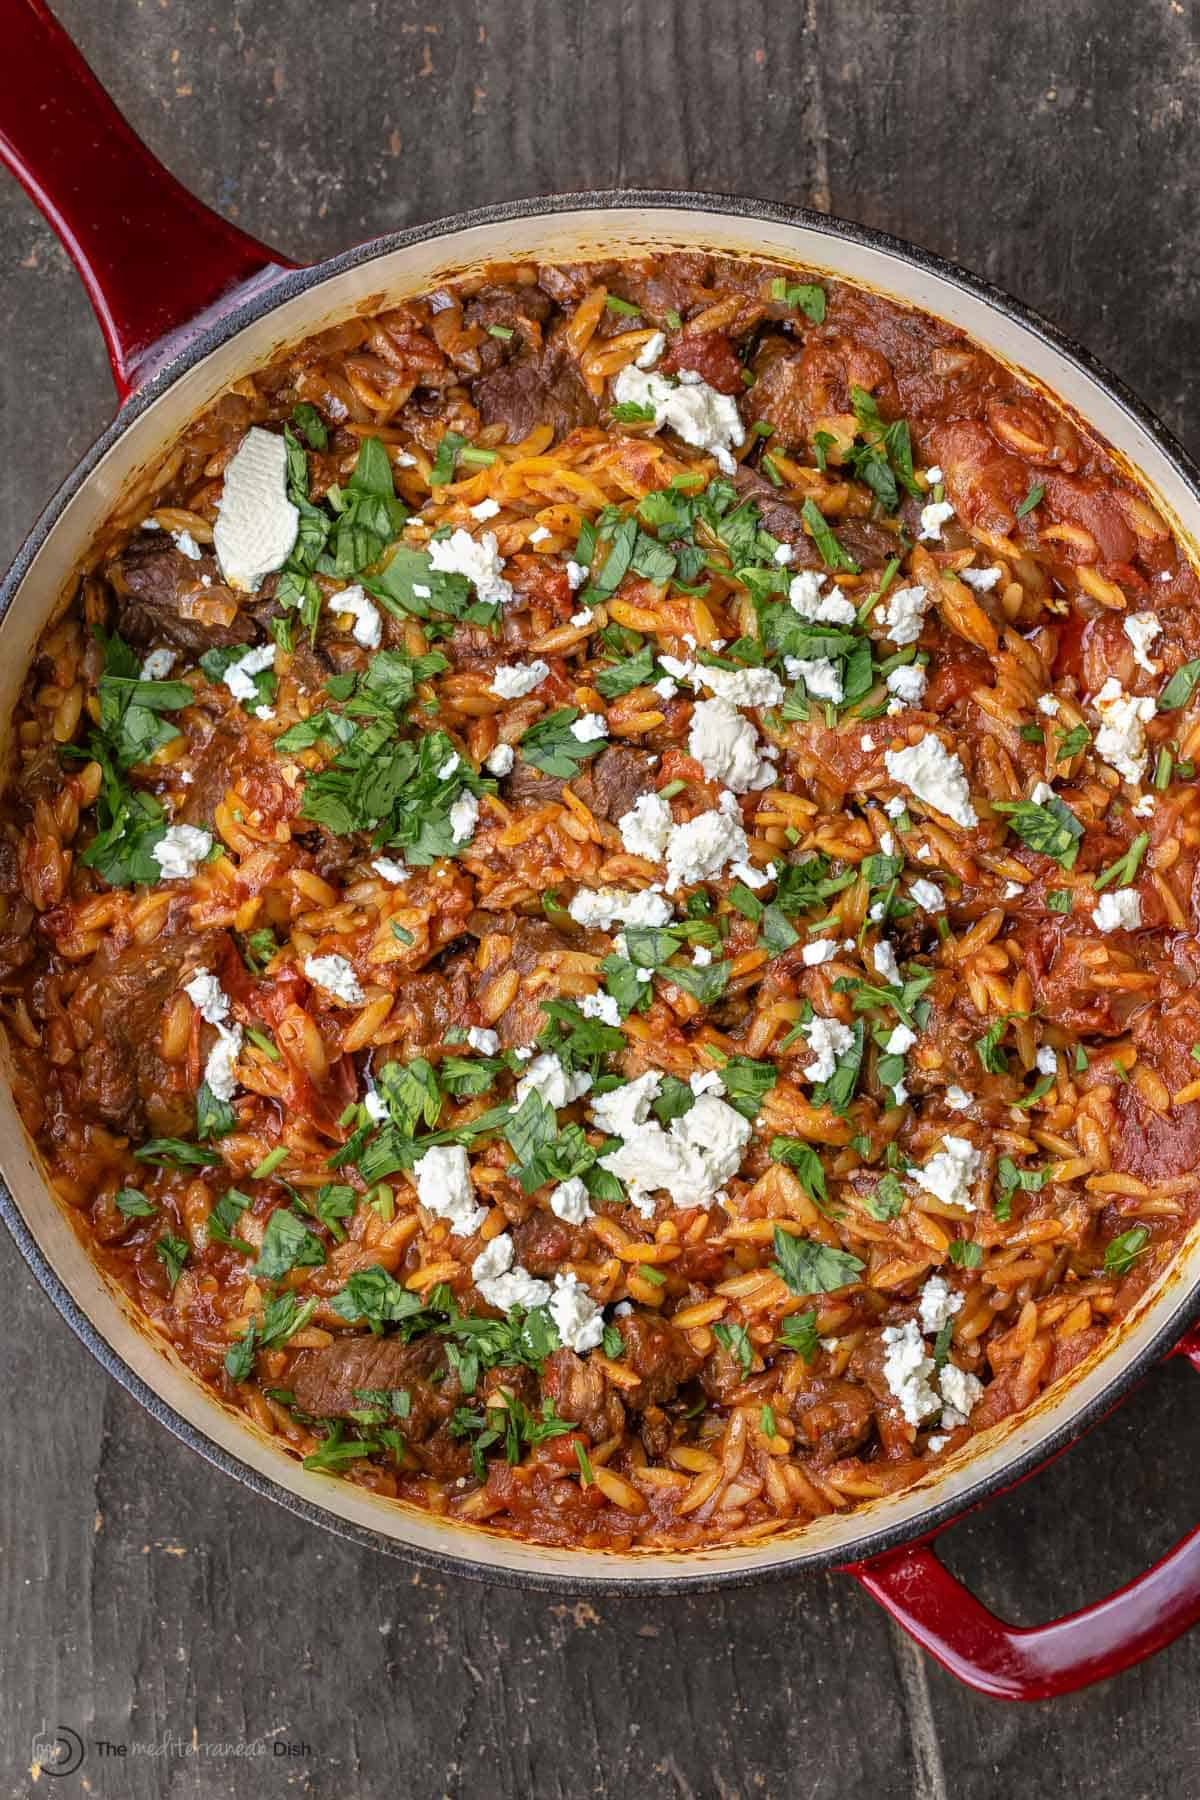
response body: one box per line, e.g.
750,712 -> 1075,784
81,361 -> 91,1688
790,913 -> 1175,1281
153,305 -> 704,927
0,0 -> 295,400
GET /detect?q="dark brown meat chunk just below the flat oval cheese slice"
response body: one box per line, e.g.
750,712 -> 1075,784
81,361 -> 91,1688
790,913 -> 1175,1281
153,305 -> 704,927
108,531 -> 259,655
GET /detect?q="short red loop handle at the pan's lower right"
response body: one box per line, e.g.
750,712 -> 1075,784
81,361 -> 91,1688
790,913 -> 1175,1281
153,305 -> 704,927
847,1328 -> 1200,1699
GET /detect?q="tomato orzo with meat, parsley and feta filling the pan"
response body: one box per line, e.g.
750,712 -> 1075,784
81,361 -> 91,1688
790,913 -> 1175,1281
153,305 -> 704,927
0,254 -> 1200,1546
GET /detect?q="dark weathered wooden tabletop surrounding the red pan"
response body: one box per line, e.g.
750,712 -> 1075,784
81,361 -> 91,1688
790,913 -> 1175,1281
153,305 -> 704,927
0,0 -> 1200,1800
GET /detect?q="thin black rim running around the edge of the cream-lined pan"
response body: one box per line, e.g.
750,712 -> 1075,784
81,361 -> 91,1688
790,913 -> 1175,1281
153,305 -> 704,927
0,189 -> 1200,1595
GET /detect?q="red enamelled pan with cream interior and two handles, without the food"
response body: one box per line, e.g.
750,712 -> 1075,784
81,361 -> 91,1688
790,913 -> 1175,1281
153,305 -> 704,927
0,0 -> 1200,1699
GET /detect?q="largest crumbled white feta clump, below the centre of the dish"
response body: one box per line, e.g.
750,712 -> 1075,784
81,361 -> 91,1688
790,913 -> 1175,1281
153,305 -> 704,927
592,1076 -> 752,1217
